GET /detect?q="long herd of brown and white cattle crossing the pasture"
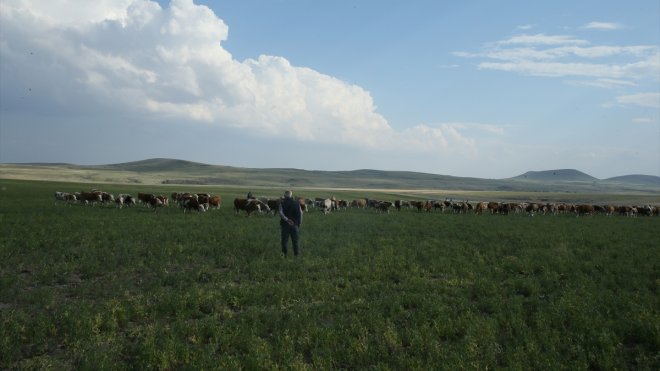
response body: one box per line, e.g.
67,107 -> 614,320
55,190 -> 660,216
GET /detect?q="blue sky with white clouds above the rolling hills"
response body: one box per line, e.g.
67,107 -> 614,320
0,0 -> 660,178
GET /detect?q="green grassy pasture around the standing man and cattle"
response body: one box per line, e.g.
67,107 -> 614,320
0,180 -> 660,370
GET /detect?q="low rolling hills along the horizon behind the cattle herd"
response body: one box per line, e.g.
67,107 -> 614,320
0,158 -> 660,194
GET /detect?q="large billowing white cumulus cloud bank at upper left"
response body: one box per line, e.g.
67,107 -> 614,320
0,0 -> 474,154
